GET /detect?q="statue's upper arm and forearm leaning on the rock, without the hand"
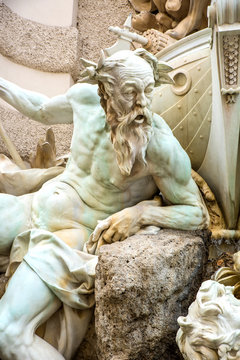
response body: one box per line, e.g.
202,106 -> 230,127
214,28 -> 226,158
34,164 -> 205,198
137,128 -> 209,230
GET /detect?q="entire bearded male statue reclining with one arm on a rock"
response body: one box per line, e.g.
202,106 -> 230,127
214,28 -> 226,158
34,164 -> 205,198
0,49 -> 209,360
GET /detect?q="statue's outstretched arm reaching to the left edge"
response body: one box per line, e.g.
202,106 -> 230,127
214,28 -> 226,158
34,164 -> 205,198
0,78 -> 73,125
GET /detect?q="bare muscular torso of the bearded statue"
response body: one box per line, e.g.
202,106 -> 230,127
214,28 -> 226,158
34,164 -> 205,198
52,83 -> 157,228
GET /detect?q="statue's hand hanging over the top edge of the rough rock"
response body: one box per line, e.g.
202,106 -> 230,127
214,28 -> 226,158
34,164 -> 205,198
91,206 -> 141,244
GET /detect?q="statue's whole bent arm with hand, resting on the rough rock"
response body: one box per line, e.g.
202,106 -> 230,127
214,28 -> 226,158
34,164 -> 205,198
89,131 -> 209,243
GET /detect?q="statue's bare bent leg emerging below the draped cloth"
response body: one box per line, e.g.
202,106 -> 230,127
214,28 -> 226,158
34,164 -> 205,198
0,261 -> 64,360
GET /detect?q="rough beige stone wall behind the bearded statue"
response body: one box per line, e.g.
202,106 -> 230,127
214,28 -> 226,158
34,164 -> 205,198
0,0 -> 132,160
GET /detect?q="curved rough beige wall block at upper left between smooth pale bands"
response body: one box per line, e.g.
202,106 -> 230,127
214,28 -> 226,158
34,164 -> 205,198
0,4 -> 78,73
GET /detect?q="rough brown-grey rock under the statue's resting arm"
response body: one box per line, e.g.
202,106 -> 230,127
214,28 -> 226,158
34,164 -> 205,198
95,230 -> 206,360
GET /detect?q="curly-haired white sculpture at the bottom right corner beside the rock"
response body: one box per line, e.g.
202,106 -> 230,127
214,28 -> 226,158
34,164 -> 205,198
177,252 -> 240,360
